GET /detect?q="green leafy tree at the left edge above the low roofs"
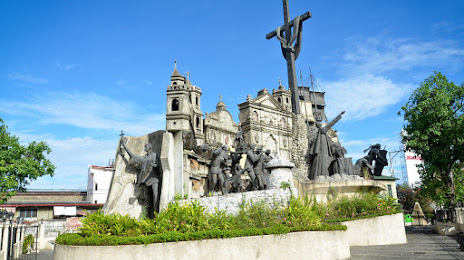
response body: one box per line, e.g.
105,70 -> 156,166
0,118 -> 55,204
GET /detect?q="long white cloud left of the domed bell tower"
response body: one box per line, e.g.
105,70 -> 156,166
0,92 -> 165,135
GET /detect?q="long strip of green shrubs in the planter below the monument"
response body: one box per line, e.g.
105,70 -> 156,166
56,193 -> 399,245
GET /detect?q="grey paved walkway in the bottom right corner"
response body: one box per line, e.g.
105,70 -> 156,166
350,226 -> 464,260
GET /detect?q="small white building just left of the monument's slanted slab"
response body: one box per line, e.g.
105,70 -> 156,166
87,165 -> 114,204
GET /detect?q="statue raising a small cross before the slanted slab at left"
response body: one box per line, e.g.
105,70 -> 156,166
120,134 -> 161,214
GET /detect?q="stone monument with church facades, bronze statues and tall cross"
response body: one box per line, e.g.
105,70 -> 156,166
103,0 -> 394,217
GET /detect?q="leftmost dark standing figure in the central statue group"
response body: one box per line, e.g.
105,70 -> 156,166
208,145 -> 230,194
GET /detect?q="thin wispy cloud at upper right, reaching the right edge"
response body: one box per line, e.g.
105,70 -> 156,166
341,36 -> 464,75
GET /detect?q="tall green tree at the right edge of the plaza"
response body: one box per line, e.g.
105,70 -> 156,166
401,72 -> 464,219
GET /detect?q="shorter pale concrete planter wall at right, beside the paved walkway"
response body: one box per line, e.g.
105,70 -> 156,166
342,213 -> 407,246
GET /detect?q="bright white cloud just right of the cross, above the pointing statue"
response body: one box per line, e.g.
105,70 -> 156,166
322,74 -> 413,120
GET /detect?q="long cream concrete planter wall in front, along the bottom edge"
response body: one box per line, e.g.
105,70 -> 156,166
54,231 -> 350,260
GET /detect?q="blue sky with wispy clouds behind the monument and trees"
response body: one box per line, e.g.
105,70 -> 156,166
0,0 -> 464,189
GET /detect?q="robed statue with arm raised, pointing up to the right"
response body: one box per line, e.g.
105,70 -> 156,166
309,111 -> 345,180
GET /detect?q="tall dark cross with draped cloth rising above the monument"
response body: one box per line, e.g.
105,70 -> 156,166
266,0 -> 311,115
